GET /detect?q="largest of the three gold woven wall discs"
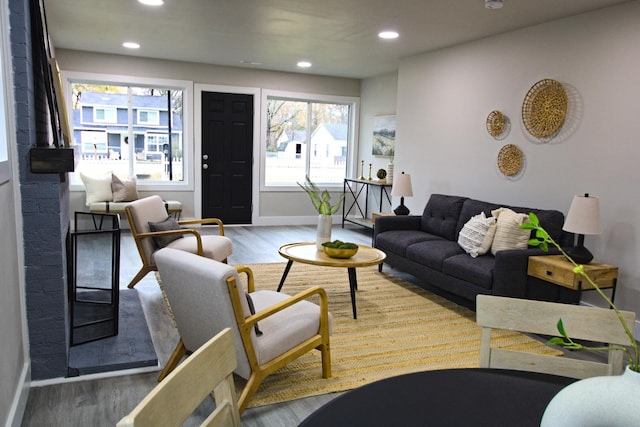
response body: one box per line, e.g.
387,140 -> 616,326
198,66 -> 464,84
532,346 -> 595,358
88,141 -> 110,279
522,79 -> 568,138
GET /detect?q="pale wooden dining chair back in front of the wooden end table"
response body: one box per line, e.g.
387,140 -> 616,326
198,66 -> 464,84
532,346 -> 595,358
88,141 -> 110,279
476,295 -> 636,379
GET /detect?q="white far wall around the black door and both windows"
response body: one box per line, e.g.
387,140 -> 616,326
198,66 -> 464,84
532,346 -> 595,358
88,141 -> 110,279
56,49 -> 360,224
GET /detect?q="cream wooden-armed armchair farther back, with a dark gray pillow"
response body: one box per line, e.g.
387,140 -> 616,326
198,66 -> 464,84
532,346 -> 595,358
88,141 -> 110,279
125,196 -> 233,288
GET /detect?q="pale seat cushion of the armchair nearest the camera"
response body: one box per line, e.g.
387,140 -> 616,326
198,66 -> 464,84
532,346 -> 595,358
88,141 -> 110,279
251,290 -> 333,365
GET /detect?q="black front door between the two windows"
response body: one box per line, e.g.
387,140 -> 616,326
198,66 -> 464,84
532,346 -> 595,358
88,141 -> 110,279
202,92 -> 253,224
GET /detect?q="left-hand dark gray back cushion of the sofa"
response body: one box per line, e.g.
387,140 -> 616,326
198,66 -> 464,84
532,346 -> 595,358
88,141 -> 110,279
422,194 -> 468,242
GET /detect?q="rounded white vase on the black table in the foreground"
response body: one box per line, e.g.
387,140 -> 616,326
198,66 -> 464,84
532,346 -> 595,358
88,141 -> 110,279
540,367 -> 640,427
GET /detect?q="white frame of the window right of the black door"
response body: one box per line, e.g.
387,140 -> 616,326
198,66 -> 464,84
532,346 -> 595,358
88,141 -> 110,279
260,89 -> 360,192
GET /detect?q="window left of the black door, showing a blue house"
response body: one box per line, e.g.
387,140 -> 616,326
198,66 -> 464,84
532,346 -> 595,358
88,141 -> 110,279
63,73 -> 193,188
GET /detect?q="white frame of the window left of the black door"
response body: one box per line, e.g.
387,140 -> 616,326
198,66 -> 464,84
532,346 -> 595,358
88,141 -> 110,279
60,70 -> 195,191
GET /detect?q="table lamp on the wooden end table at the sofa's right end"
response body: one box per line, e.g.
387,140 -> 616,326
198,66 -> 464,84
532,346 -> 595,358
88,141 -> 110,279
562,193 -> 602,264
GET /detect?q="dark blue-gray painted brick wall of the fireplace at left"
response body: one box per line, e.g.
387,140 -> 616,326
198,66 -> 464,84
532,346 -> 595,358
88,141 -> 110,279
9,0 -> 70,380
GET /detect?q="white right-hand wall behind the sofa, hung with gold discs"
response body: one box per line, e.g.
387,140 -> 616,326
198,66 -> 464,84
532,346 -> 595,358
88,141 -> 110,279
396,1 -> 640,313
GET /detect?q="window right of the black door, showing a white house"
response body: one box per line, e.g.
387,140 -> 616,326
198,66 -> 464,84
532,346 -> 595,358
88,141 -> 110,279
263,93 -> 357,189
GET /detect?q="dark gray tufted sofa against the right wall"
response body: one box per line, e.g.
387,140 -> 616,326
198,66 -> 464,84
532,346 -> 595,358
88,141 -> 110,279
373,194 -> 579,306
